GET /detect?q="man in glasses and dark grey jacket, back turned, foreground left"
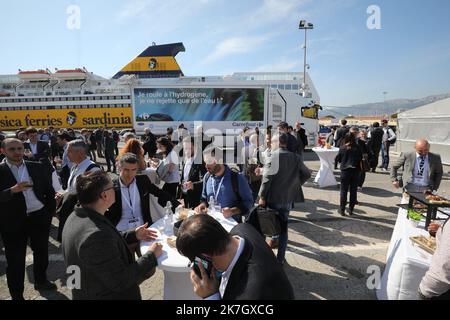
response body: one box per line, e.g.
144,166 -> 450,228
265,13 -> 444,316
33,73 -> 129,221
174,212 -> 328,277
62,171 -> 162,300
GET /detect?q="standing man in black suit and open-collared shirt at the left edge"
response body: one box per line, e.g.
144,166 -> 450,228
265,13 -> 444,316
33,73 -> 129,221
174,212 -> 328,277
0,138 -> 56,300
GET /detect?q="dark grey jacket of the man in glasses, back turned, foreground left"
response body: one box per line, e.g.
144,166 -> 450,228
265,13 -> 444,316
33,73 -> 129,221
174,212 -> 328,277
62,207 -> 158,300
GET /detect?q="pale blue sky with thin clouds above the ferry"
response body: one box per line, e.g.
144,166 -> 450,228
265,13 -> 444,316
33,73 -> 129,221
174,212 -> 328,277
0,0 -> 450,106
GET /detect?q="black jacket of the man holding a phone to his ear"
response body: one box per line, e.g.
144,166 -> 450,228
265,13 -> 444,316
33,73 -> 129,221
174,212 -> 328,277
223,223 -> 294,300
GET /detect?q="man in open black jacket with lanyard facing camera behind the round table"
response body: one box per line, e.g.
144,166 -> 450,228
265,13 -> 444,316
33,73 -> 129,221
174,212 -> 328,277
105,153 -> 180,231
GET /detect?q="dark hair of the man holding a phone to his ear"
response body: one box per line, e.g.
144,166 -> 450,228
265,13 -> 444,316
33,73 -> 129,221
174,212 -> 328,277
176,214 -> 231,261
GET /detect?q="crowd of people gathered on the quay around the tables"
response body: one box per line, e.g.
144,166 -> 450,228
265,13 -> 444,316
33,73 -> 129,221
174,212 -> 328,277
0,120 -> 450,300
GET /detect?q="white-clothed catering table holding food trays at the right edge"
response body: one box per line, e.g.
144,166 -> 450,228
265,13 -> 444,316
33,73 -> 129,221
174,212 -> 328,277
376,200 -> 441,300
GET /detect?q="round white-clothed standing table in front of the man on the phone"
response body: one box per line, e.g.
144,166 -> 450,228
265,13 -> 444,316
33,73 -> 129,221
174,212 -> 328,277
140,212 -> 237,300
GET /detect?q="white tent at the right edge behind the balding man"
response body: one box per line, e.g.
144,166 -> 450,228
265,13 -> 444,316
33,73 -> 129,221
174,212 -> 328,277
397,98 -> 450,164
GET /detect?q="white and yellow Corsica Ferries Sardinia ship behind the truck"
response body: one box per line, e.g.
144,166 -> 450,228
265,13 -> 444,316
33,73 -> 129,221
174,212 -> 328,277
0,43 -> 320,139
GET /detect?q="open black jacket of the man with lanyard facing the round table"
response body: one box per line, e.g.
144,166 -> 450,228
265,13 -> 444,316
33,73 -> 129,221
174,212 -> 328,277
105,175 -> 180,226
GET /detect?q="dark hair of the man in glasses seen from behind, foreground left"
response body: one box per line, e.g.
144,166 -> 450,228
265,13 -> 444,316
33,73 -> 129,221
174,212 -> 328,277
76,171 -> 111,205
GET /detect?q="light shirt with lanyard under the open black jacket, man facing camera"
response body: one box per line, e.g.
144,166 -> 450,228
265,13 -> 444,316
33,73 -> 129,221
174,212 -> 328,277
116,179 -> 144,231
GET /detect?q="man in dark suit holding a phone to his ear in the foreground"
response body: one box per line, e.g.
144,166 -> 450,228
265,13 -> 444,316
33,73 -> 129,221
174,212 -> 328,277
176,214 -> 294,300
